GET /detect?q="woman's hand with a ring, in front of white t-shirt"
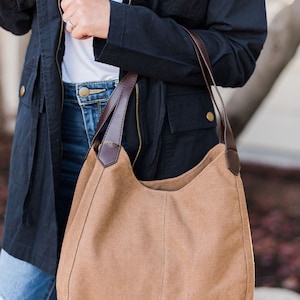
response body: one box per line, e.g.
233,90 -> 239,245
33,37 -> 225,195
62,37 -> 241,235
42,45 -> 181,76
61,0 -> 110,39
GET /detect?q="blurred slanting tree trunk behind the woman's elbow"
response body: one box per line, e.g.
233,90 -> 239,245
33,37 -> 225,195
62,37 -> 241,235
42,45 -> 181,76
226,0 -> 300,136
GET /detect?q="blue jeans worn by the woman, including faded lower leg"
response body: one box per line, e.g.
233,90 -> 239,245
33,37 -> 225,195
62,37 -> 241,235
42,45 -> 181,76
0,81 -> 117,300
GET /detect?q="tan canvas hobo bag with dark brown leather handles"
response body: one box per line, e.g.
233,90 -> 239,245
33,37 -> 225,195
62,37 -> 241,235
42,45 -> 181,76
57,29 -> 254,300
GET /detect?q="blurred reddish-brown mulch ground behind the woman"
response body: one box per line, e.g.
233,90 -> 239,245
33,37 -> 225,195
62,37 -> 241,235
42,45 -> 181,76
0,134 -> 300,293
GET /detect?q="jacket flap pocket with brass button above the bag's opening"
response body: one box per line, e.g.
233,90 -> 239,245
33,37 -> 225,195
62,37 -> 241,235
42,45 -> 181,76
166,86 -> 216,133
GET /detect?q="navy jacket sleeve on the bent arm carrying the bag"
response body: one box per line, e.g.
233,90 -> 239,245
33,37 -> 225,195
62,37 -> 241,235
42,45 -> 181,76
94,0 -> 267,87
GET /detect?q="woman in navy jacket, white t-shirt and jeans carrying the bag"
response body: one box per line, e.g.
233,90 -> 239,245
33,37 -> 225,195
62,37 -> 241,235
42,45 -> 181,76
0,0 -> 266,300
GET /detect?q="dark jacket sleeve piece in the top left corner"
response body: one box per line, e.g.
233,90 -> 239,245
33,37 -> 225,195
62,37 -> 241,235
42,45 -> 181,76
0,0 -> 35,35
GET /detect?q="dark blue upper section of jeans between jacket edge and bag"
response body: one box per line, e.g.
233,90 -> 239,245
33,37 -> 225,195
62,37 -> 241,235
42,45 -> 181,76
56,81 -> 117,246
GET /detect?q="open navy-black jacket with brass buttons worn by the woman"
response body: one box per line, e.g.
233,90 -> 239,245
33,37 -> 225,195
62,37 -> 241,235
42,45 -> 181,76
0,0 -> 266,274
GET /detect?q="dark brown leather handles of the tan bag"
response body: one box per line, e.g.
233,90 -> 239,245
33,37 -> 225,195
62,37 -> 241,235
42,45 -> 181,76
96,28 -> 240,175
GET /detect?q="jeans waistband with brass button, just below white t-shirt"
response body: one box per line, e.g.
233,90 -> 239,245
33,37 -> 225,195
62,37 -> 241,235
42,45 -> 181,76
63,80 -> 118,104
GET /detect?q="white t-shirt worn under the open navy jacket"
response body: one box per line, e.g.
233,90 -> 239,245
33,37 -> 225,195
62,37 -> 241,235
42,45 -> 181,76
62,0 -> 122,83
